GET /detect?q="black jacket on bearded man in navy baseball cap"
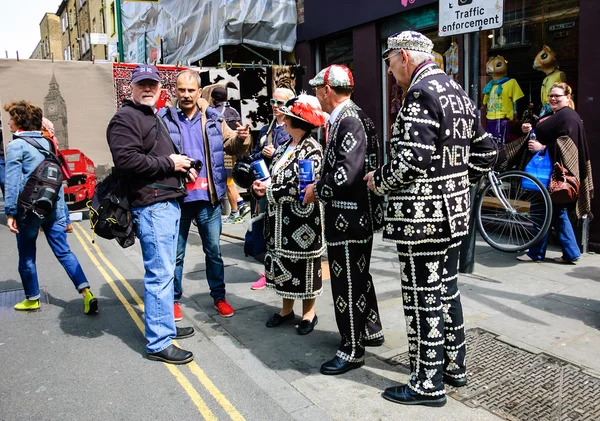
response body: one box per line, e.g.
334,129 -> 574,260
106,100 -> 186,207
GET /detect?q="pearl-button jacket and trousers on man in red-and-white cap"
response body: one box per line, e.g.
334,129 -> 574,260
315,99 -> 383,363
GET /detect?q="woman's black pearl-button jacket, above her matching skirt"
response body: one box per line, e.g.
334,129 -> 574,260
264,137 -> 325,259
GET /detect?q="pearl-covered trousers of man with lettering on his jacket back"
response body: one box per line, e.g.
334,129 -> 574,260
397,241 -> 466,396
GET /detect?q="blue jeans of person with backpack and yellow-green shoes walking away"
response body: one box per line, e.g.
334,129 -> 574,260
17,206 -> 90,300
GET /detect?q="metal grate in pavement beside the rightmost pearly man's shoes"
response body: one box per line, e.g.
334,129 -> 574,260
386,328 -> 600,421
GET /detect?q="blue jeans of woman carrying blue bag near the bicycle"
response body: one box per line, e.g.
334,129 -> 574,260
527,202 -> 581,262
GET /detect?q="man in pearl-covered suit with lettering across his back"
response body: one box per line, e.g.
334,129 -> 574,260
365,31 -> 496,406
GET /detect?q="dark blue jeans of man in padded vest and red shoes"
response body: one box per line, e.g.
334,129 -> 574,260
175,200 -> 225,301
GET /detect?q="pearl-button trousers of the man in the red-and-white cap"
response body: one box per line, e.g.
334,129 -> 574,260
327,238 -> 383,362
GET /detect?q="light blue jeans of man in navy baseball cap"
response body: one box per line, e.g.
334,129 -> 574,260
132,200 -> 180,353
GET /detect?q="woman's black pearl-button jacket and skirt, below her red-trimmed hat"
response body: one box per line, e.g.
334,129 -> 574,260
264,137 -> 325,300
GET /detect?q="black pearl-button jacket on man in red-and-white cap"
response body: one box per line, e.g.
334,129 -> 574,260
315,101 -> 383,245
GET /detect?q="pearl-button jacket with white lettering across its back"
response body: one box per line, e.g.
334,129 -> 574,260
373,64 -> 497,245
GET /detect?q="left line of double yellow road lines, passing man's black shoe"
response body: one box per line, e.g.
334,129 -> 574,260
73,224 -> 217,421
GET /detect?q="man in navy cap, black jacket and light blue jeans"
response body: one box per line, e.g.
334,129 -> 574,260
106,65 -> 196,364
